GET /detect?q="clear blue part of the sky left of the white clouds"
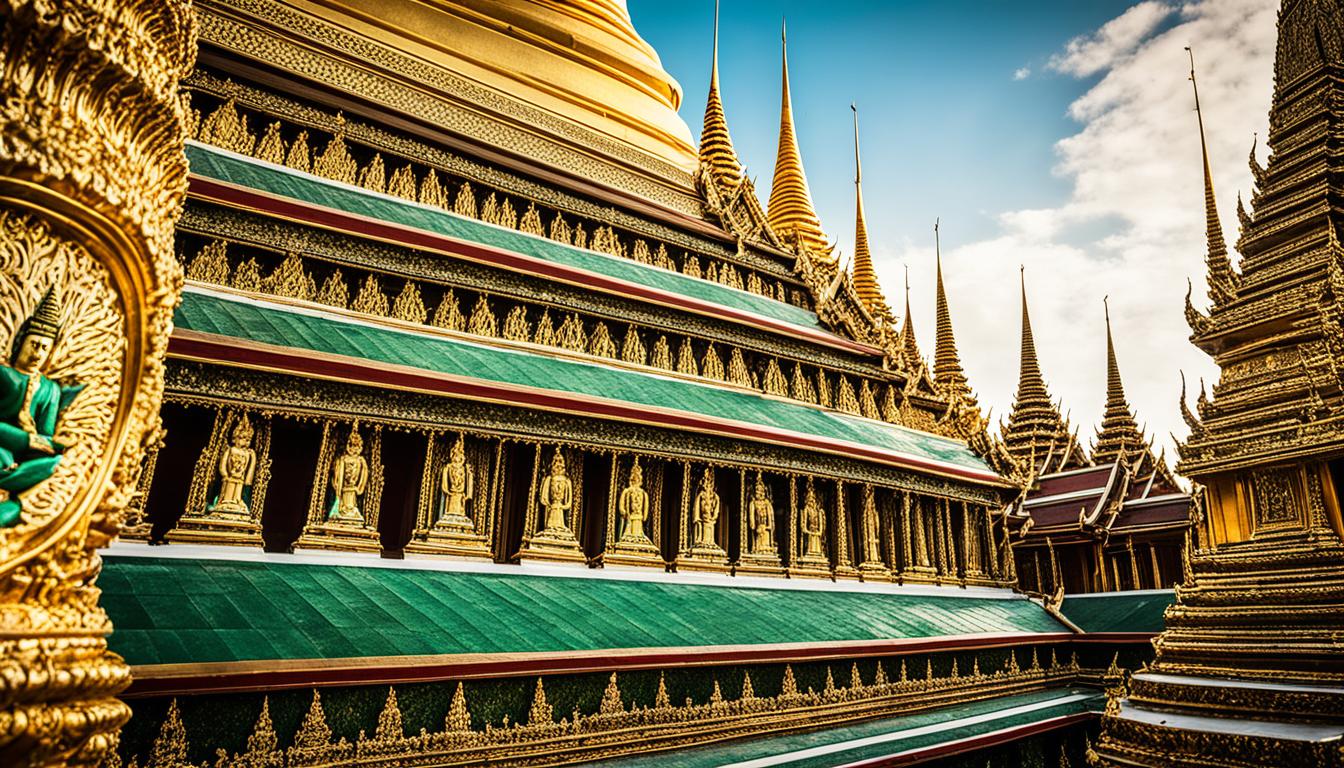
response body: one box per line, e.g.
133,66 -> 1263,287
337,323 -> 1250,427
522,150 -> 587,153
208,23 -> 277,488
629,0 -> 1145,246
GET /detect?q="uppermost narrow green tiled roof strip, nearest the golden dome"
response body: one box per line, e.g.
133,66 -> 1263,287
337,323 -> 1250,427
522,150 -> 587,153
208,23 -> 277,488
187,144 -> 821,330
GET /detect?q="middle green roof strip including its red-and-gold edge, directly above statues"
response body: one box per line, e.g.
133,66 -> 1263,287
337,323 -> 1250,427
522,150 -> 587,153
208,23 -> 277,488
169,286 -> 999,483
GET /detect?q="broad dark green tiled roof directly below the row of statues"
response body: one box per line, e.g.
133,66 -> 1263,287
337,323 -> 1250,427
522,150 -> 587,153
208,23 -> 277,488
98,554 -> 1062,664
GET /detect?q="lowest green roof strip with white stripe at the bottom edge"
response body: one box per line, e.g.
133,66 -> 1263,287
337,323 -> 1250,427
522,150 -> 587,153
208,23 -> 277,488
597,689 -> 1106,768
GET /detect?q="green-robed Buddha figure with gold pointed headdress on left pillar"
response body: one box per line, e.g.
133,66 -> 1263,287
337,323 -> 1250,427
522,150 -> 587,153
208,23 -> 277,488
0,288 -> 82,527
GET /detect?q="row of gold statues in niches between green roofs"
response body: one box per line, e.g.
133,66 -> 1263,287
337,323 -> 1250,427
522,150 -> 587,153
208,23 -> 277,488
157,410 -> 993,576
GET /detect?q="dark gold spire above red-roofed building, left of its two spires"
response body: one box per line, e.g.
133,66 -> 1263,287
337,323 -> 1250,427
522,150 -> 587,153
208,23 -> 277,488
1003,273 -> 1089,476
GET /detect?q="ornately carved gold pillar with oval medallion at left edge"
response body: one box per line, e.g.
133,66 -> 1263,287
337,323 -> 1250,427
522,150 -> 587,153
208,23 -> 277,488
0,0 -> 196,765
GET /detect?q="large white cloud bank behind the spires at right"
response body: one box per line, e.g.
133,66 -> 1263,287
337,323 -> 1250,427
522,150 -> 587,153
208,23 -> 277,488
879,0 -> 1278,468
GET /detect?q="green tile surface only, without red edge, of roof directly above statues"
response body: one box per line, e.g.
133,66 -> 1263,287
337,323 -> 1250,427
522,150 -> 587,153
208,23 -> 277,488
173,291 -> 989,473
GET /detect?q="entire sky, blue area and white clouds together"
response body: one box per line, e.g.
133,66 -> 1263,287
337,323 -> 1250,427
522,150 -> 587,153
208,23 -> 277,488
629,0 -> 1278,468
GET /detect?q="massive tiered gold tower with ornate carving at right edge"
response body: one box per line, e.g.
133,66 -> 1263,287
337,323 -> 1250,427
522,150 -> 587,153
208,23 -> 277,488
1095,0 -> 1344,767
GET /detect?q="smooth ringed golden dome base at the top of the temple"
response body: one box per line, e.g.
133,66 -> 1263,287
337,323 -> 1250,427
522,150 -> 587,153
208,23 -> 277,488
307,0 -> 698,171
